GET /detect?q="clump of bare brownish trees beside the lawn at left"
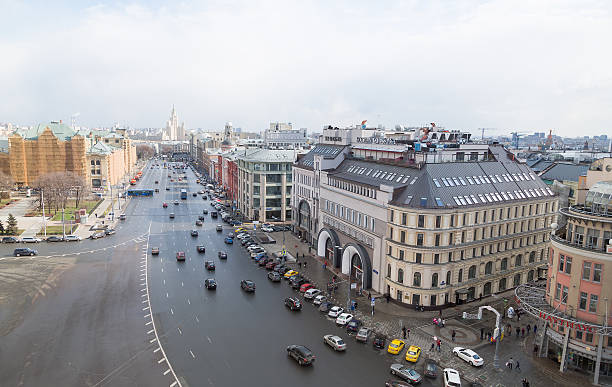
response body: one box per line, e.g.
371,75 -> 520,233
30,172 -> 87,213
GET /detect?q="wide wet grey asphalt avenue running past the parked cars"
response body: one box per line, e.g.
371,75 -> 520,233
0,163 -> 441,386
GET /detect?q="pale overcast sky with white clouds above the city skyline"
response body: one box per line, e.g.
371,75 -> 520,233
0,0 -> 612,136
